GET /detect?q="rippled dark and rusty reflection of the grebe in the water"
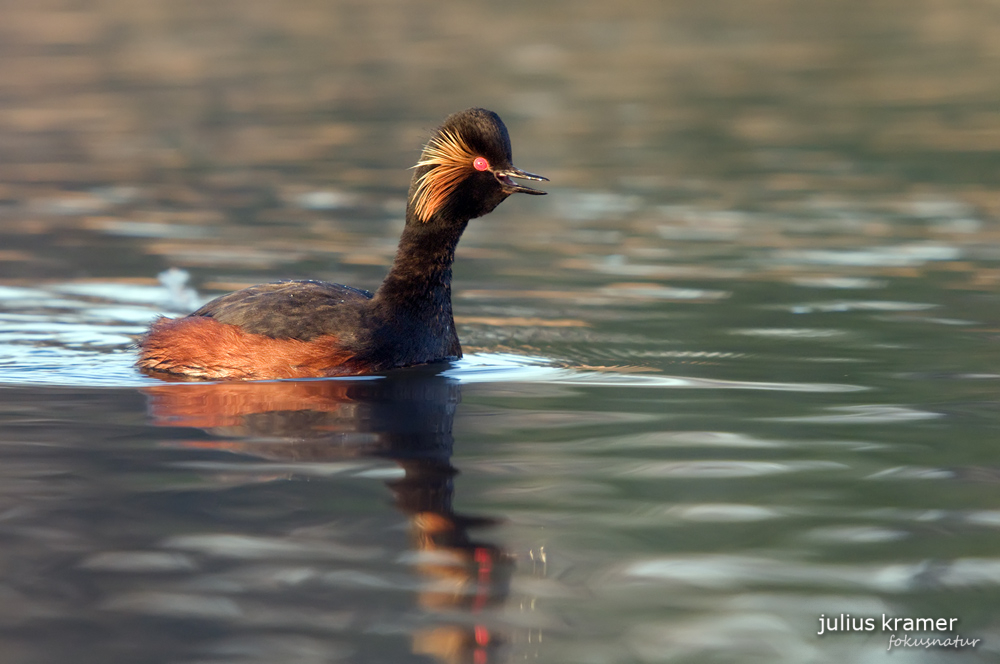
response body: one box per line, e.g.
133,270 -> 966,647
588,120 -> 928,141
144,367 -> 513,664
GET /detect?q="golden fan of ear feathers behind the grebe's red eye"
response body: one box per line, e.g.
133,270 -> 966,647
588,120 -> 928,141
413,130 -> 477,222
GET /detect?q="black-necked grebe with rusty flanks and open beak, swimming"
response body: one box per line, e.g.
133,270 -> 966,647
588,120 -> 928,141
136,108 -> 547,380
